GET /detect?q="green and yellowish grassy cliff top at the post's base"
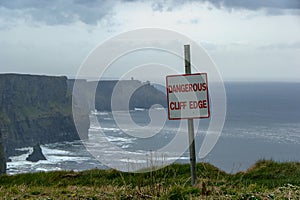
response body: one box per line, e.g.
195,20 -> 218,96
0,161 -> 300,199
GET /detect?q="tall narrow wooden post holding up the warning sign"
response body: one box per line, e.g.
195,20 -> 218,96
184,45 -> 197,186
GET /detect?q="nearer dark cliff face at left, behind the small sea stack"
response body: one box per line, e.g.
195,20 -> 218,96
0,74 -> 89,156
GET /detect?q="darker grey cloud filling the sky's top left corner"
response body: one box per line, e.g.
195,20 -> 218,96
0,0 -> 116,25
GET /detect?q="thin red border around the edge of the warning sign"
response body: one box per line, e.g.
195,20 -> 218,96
166,73 -> 210,120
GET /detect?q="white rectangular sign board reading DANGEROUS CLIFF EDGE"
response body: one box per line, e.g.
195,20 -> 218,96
166,73 -> 210,120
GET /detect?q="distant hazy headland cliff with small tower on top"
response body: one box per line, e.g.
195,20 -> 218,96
68,80 -> 167,111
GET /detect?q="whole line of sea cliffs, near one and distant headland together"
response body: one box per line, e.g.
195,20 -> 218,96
0,74 -> 166,159
